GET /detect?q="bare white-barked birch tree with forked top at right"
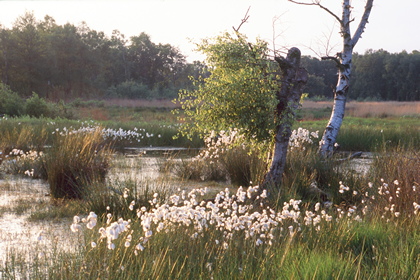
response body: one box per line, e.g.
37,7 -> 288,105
289,0 -> 373,157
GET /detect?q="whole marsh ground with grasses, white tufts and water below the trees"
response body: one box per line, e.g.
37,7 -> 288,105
0,101 -> 420,279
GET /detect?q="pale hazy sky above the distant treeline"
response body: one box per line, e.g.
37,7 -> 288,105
0,0 -> 420,61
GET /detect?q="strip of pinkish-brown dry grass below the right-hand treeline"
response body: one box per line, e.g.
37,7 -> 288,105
302,101 -> 420,118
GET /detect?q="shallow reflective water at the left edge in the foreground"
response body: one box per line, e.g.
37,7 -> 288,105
0,176 -> 78,263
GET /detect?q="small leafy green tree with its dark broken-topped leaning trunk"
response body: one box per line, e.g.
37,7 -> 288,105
178,30 -> 307,190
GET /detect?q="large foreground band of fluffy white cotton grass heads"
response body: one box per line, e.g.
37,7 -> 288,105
71,177 -> 420,255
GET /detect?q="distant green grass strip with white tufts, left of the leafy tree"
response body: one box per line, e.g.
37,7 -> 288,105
0,117 -> 203,151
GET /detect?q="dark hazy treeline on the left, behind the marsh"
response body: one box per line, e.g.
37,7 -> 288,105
0,13 -> 203,100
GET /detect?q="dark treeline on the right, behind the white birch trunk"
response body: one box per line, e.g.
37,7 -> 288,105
302,50 -> 420,101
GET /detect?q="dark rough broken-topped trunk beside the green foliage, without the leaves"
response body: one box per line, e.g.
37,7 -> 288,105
262,48 -> 308,189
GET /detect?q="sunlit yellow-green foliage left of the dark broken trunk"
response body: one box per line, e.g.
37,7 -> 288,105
178,33 -> 280,141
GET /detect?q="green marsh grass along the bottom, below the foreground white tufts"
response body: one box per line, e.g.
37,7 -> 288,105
0,183 -> 420,280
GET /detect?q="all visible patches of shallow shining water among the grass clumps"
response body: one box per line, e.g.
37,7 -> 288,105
0,148 -> 373,266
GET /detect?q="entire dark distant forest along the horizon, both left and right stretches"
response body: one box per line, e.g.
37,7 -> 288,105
0,13 -> 420,101
